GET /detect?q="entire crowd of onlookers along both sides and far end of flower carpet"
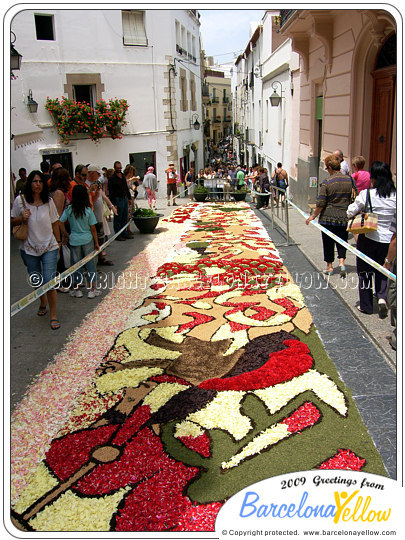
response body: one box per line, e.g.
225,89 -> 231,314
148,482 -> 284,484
11,146 -> 396,348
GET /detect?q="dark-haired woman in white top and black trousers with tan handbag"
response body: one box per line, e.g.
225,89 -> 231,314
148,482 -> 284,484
347,161 -> 397,319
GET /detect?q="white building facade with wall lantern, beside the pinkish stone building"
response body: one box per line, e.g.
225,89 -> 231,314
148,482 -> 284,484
234,11 -> 300,180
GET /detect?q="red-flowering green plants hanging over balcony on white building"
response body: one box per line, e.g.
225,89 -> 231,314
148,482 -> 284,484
45,97 -> 129,144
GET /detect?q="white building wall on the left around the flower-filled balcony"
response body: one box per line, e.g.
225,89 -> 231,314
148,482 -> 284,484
10,8 -> 203,185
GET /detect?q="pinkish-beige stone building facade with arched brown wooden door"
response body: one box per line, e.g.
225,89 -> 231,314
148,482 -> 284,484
280,9 -> 399,210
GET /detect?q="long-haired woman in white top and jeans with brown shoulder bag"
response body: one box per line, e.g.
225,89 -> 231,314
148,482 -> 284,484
11,171 -> 61,330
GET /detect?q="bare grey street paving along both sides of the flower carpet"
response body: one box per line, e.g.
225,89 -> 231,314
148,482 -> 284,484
10,192 -> 396,484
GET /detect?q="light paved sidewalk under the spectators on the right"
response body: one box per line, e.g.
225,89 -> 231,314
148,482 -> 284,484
258,205 -> 396,368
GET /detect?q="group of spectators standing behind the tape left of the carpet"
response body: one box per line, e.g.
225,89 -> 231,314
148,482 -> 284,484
11,161 -> 157,330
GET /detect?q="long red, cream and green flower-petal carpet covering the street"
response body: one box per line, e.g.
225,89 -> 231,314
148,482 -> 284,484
11,203 -> 386,532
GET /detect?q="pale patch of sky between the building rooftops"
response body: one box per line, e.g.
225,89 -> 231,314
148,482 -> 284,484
198,9 -> 265,64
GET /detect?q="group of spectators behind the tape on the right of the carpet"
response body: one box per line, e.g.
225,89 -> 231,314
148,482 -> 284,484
306,150 -> 396,349
